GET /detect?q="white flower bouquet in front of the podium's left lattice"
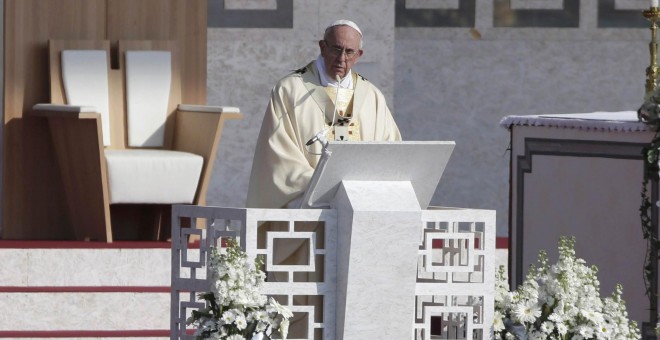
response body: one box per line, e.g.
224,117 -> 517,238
187,239 -> 293,340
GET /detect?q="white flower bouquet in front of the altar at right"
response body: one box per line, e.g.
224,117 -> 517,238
493,237 -> 640,340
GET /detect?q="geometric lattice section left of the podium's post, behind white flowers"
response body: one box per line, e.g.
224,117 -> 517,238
171,206 -> 337,339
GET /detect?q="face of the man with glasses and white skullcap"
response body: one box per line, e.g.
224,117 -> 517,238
319,26 -> 362,79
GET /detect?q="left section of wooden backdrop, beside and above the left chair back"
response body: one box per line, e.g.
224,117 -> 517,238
2,0 -> 106,239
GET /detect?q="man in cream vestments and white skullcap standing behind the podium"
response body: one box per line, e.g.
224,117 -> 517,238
246,20 -> 401,208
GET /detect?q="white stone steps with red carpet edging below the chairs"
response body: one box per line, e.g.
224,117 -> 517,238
0,238 -> 508,339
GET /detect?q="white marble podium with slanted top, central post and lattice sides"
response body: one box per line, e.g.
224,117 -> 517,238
171,142 -> 495,340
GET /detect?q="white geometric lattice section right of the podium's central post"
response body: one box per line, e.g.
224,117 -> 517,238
413,209 -> 495,340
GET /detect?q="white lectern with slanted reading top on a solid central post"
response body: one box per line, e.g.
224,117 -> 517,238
302,142 -> 455,340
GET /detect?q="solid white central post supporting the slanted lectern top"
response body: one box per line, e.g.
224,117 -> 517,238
334,181 -> 421,340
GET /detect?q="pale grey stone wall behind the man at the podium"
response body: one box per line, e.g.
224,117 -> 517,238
208,0 -> 650,236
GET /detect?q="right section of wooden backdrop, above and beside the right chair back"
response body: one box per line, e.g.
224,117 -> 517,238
108,0 -> 207,104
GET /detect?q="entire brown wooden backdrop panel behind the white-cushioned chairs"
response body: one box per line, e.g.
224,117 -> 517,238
1,0 -> 207,239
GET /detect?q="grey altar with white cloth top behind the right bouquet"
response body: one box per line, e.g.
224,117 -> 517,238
500,111 -> 658,329
